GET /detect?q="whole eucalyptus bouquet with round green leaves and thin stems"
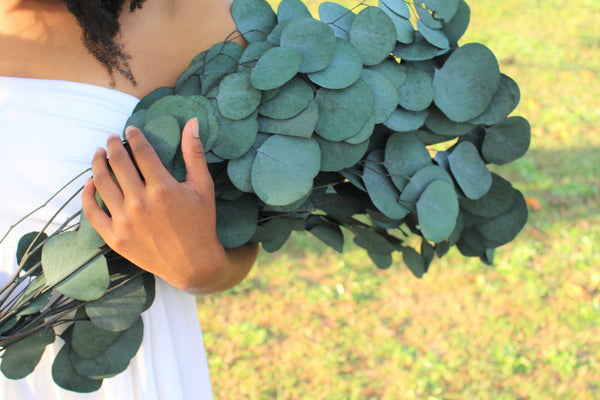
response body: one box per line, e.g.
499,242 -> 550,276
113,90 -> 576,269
0,0 -> 530,391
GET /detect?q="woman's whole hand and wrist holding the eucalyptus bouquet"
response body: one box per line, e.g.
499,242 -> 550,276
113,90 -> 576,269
82,118 -> 258,294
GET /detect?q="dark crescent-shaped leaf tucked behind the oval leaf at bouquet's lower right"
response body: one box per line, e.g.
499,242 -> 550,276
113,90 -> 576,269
460,173 -> 515,218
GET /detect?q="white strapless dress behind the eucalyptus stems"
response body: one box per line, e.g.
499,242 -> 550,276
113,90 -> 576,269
0,77 -> 212,400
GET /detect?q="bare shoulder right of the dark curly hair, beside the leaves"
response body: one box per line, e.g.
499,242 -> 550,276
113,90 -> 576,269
119,0 -> 236,96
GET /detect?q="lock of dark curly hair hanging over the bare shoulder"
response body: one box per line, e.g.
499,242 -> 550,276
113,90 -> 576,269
62,0 -> 145,85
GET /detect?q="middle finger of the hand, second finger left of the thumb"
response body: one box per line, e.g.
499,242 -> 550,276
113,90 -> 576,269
106,135 -> 144,197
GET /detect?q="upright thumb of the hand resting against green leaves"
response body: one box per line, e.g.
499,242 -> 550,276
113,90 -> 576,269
181,118 -> 213,188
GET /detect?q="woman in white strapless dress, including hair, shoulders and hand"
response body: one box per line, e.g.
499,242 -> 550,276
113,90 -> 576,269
0,0 -> 257,400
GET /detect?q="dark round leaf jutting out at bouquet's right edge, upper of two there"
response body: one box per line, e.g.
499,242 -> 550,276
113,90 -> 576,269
481,117 -> 531,165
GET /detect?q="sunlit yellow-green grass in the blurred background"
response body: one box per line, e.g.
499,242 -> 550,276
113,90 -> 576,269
198,0 -> 600,400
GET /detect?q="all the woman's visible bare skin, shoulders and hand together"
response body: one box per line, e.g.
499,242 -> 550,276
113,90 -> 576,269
0,0 -> 258,294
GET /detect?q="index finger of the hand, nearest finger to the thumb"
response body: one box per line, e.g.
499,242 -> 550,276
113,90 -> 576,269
125,126 -> 171,182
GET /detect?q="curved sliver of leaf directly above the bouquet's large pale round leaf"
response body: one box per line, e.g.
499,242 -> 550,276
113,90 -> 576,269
258,100 -> 319,138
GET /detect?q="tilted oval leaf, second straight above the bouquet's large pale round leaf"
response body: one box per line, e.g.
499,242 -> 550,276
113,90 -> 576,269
258,77 -> 315,119
